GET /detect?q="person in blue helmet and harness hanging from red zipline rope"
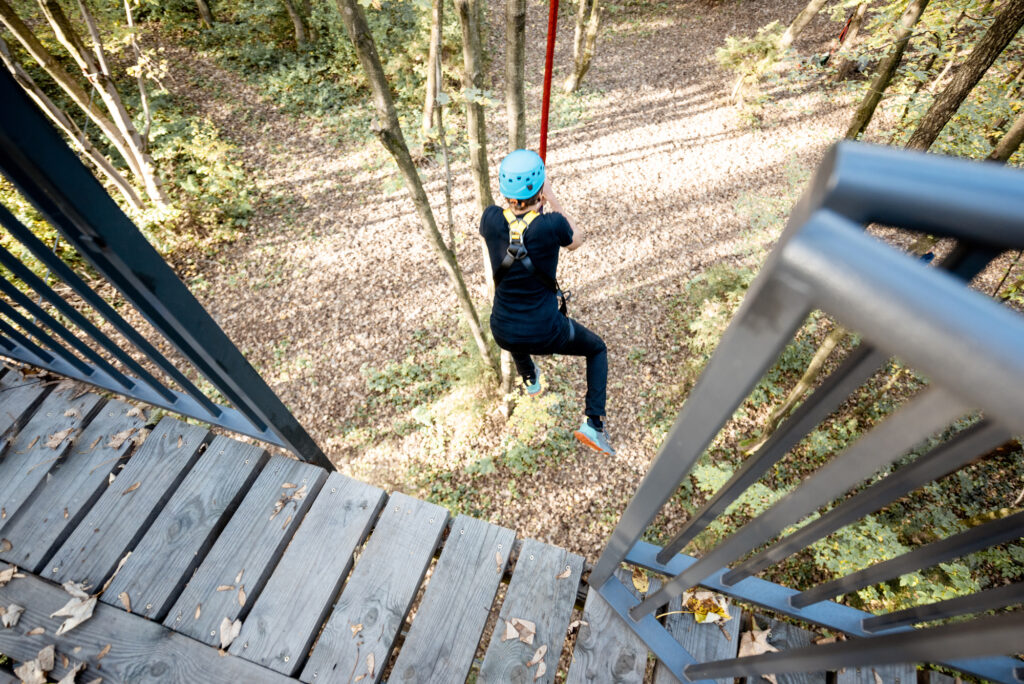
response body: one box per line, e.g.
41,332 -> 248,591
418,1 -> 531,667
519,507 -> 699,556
480,149 -> 615,456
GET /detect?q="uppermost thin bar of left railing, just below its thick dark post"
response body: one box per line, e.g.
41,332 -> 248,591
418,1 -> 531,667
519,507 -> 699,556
0,200 -> 205,409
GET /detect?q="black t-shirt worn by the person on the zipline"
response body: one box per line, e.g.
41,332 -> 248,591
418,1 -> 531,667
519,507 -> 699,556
480,202 -> 572,344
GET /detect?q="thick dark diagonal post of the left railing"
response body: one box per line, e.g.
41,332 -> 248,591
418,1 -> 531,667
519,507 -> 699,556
0,68 -> 325,470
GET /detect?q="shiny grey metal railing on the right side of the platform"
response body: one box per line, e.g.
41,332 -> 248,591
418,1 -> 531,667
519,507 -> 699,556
590,142 -> 1024,682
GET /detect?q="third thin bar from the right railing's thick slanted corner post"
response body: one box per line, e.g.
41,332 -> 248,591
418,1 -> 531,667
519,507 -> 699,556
724,420 -> 1010,585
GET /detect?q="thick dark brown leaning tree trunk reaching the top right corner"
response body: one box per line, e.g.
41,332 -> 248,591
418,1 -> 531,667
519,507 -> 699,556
906,0 -> 1024,149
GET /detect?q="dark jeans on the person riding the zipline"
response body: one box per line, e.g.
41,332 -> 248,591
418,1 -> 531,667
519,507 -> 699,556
493,318 -> 608,417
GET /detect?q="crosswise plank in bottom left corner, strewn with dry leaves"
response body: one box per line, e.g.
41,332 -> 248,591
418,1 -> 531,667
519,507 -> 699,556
0,574 -> 290,684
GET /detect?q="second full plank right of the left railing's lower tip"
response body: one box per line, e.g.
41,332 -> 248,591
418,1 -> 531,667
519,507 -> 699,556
300,494 -> 449,684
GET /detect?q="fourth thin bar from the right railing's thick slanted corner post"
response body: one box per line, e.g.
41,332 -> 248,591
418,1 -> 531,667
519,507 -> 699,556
790,511 -> 1024,608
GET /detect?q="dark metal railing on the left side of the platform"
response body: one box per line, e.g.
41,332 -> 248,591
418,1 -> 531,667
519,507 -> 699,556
0,70 -> 334,470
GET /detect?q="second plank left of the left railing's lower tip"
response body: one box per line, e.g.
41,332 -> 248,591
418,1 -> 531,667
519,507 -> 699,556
101,436 -> 268,621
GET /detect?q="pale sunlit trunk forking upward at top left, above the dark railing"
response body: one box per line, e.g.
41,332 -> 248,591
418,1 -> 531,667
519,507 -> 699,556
39,0 -> 168,206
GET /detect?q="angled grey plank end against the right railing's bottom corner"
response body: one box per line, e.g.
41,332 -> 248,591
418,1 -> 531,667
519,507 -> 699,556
565,569 -> 660,684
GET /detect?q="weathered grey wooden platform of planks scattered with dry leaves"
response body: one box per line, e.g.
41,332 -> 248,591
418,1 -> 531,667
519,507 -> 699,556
0,371 -> 929,684
